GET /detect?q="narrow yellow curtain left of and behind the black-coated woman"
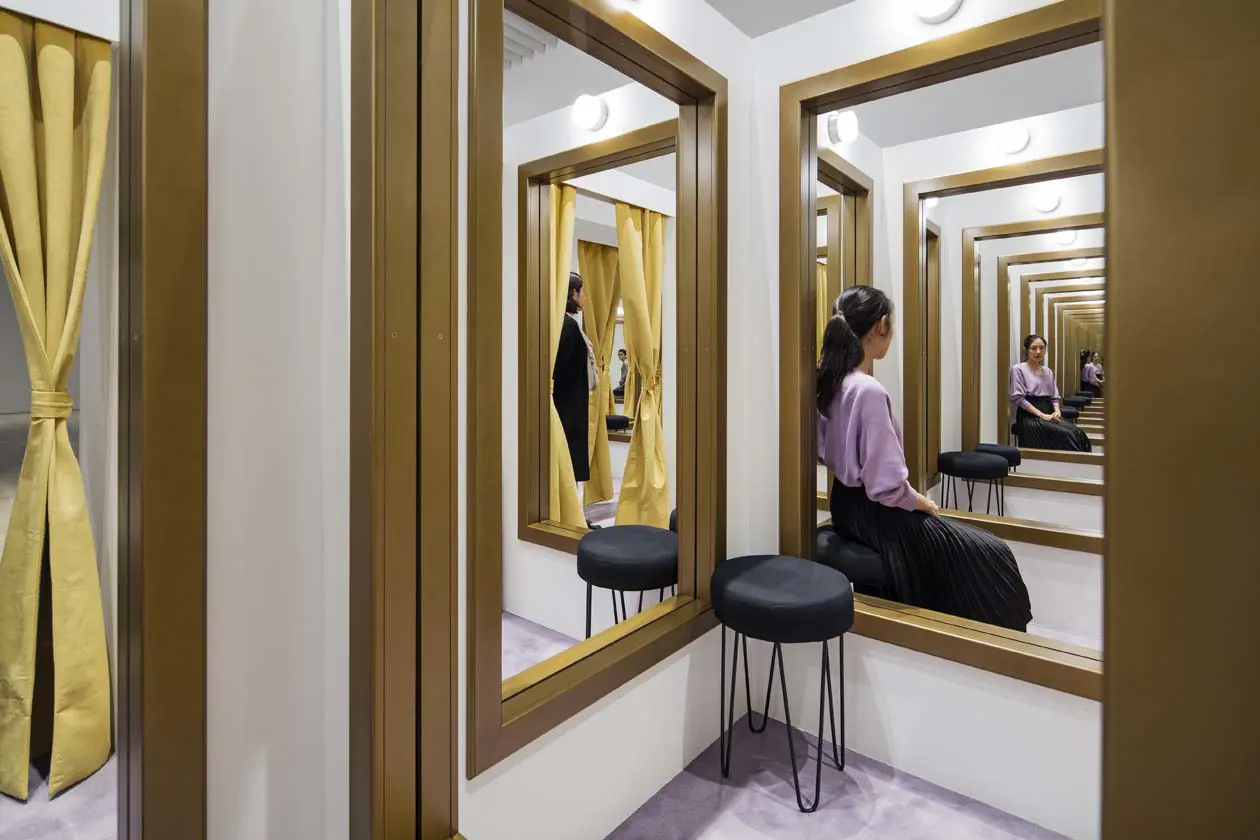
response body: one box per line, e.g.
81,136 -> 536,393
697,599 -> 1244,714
547,184 -> 586,528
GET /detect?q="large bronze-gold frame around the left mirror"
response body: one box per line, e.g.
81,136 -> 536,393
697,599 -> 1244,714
471,0 -> 727,778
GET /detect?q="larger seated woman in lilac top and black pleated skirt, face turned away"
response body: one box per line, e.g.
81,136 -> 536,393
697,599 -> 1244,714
816,286 -> 1032,631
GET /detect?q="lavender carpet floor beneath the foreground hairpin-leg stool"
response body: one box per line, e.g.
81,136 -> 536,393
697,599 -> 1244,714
606,720 -> 1062,840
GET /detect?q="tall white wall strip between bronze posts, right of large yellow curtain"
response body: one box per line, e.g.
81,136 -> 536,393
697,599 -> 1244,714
207,0 -> 349,840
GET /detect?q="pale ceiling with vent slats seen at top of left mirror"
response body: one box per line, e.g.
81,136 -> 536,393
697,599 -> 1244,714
503,11 -> 630,126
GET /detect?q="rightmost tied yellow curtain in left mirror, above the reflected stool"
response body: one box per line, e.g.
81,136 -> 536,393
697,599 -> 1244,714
616,203 -> 669,528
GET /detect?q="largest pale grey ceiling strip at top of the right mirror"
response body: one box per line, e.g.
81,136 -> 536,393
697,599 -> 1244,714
854,44 -> 1104,149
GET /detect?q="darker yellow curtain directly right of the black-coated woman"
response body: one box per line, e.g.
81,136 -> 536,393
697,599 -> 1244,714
577,241 -> 621,505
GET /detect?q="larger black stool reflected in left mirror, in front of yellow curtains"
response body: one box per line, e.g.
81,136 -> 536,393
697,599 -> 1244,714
577,525 -> 678,639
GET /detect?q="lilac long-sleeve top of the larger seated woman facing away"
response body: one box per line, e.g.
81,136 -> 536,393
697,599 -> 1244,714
818,370 -> 919,510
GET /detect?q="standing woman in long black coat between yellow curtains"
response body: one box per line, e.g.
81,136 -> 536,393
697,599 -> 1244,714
552,272 -> 597,481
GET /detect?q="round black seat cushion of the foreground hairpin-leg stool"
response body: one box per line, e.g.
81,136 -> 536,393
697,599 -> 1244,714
709,554 -> 853,645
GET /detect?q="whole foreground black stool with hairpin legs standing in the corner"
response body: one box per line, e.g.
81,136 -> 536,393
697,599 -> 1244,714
709,555 -> 853,814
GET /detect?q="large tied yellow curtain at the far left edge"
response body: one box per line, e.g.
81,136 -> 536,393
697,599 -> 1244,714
0,11 -> 111,800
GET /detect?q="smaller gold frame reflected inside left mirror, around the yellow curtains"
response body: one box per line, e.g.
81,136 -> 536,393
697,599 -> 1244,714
516,120 -> 680,551
